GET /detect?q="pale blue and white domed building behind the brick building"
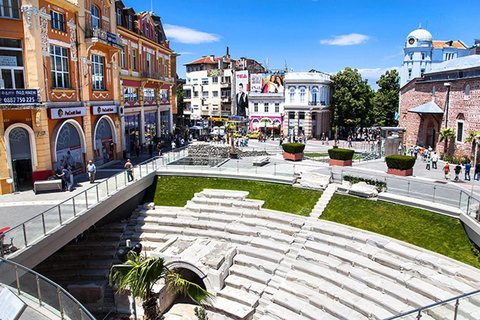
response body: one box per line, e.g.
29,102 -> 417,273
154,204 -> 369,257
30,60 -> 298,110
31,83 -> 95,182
400,25 -> 469,87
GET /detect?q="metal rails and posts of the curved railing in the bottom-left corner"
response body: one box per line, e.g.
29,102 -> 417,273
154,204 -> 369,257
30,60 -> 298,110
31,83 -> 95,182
0,258 -> 95,320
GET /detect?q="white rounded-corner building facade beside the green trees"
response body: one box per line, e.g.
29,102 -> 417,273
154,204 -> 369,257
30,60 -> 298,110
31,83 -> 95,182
283,71 -> 333,139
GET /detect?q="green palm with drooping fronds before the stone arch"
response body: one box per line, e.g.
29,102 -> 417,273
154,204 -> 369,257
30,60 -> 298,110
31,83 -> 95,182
110,251 -> 212,319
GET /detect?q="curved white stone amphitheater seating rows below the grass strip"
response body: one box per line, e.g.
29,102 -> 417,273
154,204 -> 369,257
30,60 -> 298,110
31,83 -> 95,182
133,190 -> 480,320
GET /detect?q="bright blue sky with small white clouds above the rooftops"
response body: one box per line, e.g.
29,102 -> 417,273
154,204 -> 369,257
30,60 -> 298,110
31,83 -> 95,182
123,0 -> 480,88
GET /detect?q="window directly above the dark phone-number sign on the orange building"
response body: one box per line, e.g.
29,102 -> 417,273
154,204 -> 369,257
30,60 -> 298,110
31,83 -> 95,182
0,38 -> 25,89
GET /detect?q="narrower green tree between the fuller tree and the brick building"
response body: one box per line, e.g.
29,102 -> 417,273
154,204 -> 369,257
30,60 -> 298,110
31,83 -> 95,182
371,70 -> 400,126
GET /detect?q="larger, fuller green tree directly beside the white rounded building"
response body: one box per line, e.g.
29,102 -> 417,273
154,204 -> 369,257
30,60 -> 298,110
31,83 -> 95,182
333,67 -> 373,127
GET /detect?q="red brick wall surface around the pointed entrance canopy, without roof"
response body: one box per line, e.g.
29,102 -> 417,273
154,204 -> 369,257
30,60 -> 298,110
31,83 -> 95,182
399,78 -> 480,156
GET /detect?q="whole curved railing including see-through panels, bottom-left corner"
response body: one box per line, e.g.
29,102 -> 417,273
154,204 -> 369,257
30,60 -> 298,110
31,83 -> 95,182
0,258 -> 95,320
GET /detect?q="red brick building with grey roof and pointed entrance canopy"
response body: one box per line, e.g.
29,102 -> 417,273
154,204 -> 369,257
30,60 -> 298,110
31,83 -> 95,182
399,55 -> 480,156
